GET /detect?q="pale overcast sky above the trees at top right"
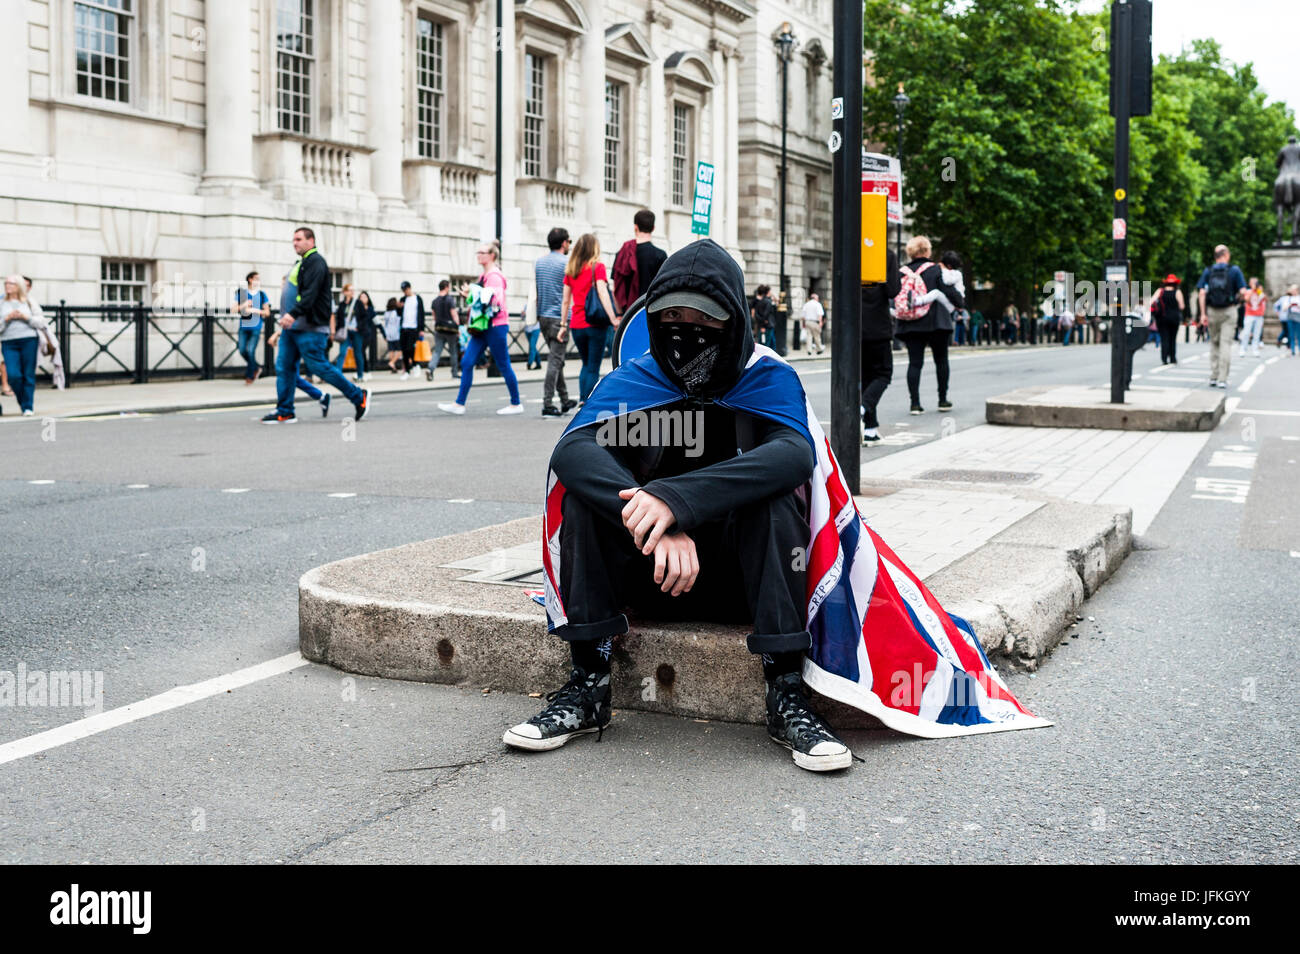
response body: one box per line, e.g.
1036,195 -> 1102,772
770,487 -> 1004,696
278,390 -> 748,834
1079,0 -> 1300,113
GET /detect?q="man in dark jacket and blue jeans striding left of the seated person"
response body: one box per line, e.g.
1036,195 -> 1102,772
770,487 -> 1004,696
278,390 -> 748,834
261,226 -> 371,424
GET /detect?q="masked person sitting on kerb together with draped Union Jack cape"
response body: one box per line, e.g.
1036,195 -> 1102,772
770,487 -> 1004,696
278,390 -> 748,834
503,239 -> 1047,771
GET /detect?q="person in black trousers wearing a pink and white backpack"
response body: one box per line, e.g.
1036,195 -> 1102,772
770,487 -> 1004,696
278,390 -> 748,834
894,235 -> 966,415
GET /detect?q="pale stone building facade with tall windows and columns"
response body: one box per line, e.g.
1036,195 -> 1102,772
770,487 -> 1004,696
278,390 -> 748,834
0,0 -> 831,321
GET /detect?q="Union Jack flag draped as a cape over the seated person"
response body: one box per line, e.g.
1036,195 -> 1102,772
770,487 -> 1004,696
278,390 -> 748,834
542,344 -> 1052,738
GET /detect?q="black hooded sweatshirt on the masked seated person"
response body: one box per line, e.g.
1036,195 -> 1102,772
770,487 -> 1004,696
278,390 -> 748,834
551,239 -> 815,532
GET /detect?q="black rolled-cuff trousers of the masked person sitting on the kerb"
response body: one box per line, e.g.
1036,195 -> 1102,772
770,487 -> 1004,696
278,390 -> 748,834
555,493 -> 813,652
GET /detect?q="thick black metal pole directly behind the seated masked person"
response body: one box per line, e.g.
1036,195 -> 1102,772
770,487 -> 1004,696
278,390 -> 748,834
819,0 -> 862,494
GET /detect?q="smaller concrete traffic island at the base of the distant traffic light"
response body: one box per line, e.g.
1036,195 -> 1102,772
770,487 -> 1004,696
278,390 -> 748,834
984,385 -> 1223,430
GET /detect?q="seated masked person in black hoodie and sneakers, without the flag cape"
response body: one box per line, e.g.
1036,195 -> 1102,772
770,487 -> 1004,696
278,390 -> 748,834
503,239 -> 852,772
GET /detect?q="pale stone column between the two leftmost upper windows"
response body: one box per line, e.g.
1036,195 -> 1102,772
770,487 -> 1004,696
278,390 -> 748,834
200,0 -> 257,192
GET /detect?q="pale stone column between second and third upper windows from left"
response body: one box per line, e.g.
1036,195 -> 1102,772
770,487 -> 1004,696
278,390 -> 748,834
369,0 -> 403,205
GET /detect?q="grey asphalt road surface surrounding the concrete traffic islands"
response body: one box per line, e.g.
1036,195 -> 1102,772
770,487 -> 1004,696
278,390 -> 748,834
0,337 -> 1300,863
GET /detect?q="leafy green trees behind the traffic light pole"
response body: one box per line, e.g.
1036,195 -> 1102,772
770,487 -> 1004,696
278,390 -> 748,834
863,0 -> 1294,307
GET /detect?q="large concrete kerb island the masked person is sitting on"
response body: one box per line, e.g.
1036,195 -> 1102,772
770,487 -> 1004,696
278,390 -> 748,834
298,487 -> 1132,728
